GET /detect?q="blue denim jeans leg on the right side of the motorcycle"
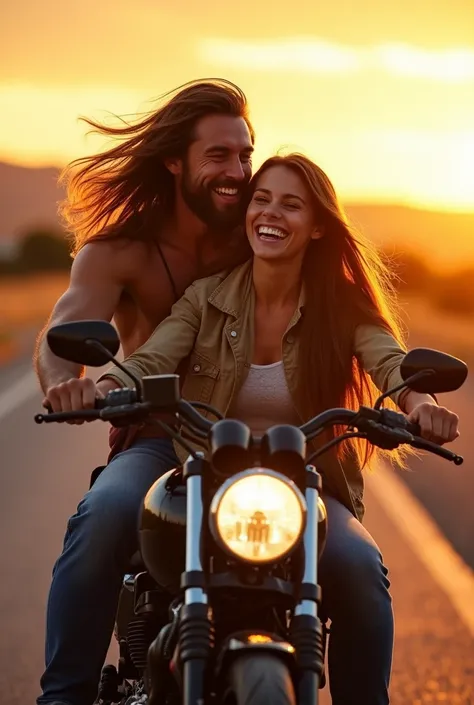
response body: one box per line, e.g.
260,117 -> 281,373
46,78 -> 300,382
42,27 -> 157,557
319,496 -> 394,705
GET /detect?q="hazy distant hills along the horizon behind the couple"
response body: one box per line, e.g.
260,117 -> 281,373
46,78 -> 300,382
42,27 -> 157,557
0,162 -> 474,268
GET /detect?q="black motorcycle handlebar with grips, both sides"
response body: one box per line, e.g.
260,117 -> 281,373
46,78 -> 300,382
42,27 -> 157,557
35,388 -> 463,465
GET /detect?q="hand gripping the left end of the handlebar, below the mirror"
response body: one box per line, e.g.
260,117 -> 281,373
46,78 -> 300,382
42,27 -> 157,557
43,377 -> 120,425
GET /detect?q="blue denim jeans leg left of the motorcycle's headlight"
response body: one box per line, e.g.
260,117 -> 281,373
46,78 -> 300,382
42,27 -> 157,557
37,438 -> 179,705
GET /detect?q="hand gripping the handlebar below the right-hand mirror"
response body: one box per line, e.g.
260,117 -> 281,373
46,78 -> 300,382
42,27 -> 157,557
404,391 -> 459,445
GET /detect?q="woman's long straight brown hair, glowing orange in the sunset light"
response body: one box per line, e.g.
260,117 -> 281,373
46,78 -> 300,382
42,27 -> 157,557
250,154 -> 406,465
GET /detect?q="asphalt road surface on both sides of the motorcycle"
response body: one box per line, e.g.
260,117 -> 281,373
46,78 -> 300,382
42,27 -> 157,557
0,350 -> 474,705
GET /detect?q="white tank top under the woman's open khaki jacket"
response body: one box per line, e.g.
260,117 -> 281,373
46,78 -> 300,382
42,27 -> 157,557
227,361 -> 301,436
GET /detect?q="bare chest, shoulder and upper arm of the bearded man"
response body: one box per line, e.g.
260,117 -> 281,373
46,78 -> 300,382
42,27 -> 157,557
36,232 -> 248,392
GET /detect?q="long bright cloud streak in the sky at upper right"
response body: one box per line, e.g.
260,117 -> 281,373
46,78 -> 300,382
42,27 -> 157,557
198,37 -> 474,83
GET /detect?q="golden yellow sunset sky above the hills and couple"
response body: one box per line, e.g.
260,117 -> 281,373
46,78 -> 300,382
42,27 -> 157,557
0,0 -> 474,211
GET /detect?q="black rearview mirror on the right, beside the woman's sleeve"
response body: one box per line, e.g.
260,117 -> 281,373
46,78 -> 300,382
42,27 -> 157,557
400,348 -> 468,394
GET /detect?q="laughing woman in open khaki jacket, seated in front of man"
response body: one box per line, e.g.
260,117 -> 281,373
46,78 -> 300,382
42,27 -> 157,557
44,154 -> 458,705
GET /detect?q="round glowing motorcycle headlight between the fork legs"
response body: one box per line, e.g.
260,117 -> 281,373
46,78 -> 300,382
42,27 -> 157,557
210,468 -> 306,564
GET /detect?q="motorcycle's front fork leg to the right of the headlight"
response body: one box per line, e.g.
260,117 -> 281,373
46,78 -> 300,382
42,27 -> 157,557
290,465 -> 324,705
